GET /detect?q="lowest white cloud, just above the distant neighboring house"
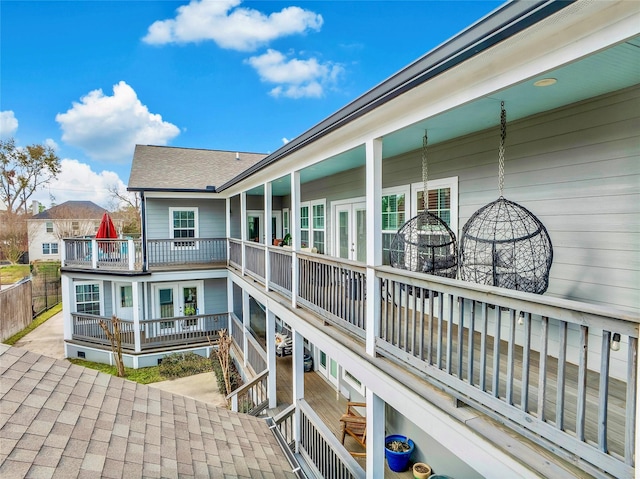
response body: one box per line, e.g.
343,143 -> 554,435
32,158 -> 127,209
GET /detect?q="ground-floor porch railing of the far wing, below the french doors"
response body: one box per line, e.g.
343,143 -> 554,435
71,313 -> 229,353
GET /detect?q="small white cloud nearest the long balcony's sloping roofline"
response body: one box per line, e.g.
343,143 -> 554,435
246,49 -> 344,98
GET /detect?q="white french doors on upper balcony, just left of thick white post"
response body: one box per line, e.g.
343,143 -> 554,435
334,202 -> 367,263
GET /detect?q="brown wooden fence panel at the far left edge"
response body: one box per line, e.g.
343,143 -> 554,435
0,279 -> 33,341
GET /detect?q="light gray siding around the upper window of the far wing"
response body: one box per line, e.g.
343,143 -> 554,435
146,198 -> 226,239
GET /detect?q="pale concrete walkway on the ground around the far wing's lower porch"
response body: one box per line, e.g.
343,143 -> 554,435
14,312 -> 227,408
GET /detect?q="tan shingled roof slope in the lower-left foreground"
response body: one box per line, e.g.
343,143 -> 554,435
0,344 -> 295,479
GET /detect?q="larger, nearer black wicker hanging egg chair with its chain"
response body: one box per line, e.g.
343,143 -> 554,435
460,102 -> 553,294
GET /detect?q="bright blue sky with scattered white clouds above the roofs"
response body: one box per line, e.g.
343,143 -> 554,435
0,0 -> 502,207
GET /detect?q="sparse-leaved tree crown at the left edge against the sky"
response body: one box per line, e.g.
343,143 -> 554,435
0,138 -> 60,214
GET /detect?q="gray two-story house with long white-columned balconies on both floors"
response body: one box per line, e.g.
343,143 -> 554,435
57,1 -> 640,478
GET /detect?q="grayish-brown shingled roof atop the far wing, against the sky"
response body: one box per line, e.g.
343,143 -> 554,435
128,145 -> 266,191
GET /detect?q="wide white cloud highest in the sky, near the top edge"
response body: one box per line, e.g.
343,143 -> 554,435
143,0 -> 323,51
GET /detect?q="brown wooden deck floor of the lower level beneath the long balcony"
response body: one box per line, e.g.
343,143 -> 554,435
276,356 -> 413,479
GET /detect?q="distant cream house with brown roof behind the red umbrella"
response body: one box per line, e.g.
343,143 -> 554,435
27,201 -> 121,261
